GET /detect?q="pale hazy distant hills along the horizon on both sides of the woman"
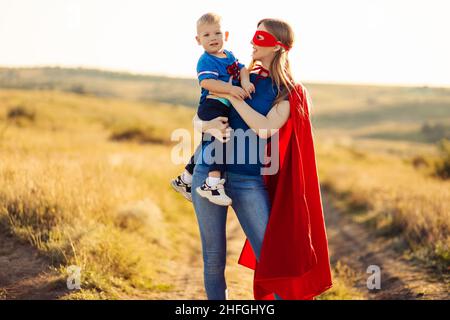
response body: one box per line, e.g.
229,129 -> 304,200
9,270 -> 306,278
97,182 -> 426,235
0,67 -> 450,143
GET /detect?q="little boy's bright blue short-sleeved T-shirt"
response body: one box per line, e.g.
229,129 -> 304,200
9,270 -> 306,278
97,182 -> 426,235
197,50 -> 244,104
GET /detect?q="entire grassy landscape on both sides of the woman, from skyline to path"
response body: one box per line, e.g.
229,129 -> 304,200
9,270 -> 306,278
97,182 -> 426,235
0,68 -> 450,298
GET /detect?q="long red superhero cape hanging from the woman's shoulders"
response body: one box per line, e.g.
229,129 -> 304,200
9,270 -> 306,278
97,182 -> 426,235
239,85 -> 332,300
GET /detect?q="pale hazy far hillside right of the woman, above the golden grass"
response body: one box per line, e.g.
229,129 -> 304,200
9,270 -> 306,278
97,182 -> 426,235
308,85 -> 450,144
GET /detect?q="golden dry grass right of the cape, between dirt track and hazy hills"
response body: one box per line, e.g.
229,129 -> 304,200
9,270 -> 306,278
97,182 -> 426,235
318,144 -> 450,272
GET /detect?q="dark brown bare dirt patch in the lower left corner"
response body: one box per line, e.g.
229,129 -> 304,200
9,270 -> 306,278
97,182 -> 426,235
0,228 -> 67,300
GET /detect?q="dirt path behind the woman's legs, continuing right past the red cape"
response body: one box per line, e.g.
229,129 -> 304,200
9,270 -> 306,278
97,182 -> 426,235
159,194 -> 450,300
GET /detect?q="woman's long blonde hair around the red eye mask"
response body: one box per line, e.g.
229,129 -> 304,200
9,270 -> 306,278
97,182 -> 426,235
249,19 -> 295,105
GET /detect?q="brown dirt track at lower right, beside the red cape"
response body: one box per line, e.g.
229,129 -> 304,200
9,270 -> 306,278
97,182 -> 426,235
323,194 -> 450,300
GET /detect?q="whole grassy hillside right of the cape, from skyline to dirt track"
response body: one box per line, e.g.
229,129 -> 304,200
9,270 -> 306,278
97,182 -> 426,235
308,85 -> 450,276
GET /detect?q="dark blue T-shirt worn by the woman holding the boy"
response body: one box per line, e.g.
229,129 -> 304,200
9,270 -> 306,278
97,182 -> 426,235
199,73 -> 278,175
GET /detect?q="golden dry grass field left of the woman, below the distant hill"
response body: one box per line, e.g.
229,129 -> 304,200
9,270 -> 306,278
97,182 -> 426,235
0,90 -> 196,298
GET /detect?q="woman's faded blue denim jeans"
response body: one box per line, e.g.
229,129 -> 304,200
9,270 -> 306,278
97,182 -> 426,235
192,164 -> 279,300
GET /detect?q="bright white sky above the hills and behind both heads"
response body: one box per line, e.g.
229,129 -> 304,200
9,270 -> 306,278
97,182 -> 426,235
0,0 -> 450,86
